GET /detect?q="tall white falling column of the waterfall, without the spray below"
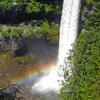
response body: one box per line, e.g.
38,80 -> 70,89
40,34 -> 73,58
58,0 -> 80,83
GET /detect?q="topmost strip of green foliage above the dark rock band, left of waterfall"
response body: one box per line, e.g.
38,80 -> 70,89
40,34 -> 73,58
0,0 -> 62,13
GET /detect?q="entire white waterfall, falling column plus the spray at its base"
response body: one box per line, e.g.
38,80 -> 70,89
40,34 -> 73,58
32,0 -> 80,92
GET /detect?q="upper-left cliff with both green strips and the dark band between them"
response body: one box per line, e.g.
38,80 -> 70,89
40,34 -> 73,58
0,0 -> 62,44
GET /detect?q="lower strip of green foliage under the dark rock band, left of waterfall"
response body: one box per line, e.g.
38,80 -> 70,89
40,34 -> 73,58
0,20 -> 59,44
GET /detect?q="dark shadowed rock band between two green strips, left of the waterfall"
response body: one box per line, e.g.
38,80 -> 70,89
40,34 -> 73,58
0,6 -> 61,25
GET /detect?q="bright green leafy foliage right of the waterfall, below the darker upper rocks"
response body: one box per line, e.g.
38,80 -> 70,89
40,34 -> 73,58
61,31 -> 100,100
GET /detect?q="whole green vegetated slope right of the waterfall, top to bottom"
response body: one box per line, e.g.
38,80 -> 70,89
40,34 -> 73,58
60,0 -> 100,100
